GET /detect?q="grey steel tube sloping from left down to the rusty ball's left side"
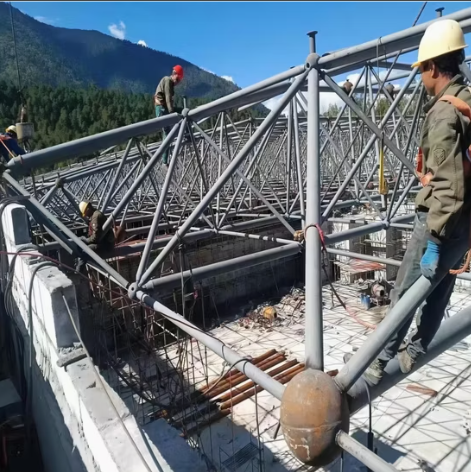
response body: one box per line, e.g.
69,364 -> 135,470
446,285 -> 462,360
135,290 -> 285,400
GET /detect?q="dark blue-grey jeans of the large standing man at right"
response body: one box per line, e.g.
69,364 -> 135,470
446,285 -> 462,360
378,212 -> 470,362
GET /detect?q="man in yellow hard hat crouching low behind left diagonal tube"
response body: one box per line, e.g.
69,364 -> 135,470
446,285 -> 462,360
76,202 -> 115,272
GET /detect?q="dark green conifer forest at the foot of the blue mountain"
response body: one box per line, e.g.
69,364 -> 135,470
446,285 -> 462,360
0,81 -> 266,149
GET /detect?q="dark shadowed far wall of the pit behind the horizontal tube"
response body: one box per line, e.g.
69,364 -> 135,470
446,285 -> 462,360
107,224 -> 306,324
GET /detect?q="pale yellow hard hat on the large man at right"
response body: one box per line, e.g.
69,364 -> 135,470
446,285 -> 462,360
412,20 -> 468,68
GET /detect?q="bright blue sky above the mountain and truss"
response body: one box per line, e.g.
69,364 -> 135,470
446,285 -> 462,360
13,1 -> 471,87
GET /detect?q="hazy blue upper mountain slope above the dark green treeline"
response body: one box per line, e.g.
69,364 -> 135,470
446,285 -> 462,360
0,2 -> 242,99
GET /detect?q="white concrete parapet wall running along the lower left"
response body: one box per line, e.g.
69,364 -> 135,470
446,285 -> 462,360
1,204 -> 206,472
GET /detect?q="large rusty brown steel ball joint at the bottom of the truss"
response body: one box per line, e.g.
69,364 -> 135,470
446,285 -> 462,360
280,369 -> 350,467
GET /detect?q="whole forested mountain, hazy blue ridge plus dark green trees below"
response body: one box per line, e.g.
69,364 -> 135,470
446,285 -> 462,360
0,2 -> 267,168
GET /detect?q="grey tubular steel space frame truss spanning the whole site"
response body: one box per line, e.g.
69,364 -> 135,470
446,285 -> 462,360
2,8 -> 471,470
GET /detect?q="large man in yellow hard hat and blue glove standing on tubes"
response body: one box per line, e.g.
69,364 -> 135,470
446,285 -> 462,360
344,19 -> 471,385
